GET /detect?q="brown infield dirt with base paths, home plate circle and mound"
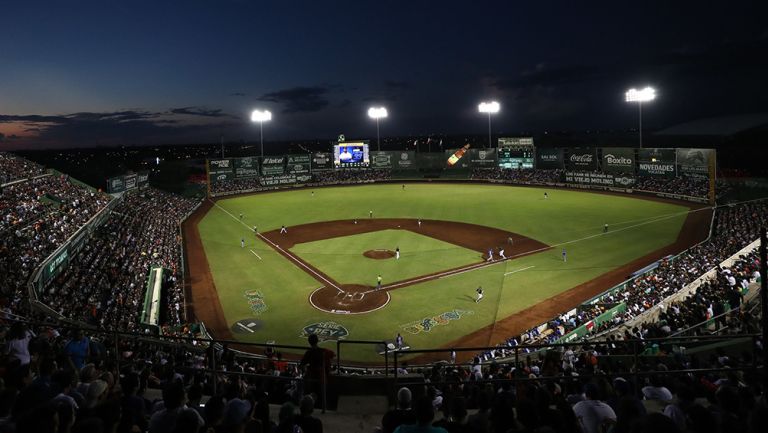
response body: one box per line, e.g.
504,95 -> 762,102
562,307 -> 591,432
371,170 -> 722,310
260,218 -> 550,314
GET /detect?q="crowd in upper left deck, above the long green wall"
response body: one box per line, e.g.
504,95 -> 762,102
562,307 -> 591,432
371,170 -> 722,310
0,176 -> 110,307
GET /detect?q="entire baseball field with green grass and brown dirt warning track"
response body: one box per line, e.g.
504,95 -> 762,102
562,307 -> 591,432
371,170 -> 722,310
184,183 -> 711,363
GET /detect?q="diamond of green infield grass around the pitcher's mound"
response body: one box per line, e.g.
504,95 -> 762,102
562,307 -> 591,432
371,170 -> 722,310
291,230 -> 482,286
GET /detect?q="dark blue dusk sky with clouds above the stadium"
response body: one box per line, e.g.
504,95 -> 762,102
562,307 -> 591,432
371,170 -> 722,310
0,0 -> 768,149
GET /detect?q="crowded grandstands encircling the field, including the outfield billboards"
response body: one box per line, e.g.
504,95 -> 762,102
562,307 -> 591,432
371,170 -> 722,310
0,149 -> 768,432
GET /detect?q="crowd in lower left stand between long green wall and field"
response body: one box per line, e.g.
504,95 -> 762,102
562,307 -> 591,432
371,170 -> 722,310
41,188 -> 196,331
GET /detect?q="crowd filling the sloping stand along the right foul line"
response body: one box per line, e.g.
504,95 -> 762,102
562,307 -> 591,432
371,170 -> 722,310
480,200 -> 768,361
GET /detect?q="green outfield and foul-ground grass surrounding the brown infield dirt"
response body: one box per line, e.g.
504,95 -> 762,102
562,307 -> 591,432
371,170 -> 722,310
199,184 -> 688,361
